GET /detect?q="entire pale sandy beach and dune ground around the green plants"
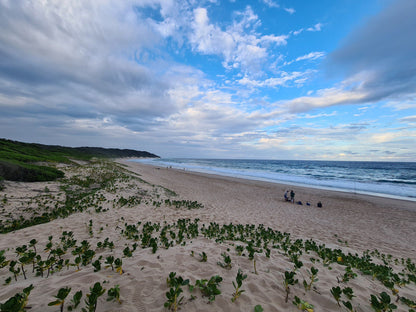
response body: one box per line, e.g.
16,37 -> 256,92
0,159 -> 416,311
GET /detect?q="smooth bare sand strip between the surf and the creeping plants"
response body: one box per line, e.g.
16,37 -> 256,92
117,159 -> 416,258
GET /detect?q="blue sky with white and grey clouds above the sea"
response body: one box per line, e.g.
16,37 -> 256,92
0,0 -> 416,161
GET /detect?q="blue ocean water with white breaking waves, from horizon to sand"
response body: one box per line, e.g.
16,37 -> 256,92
133,158 -> 416,201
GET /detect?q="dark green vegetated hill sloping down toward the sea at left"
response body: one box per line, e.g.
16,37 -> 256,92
0,139 -> 159,184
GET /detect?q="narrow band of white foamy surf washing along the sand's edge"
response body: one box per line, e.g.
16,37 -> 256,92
128,158 -> 416,202
